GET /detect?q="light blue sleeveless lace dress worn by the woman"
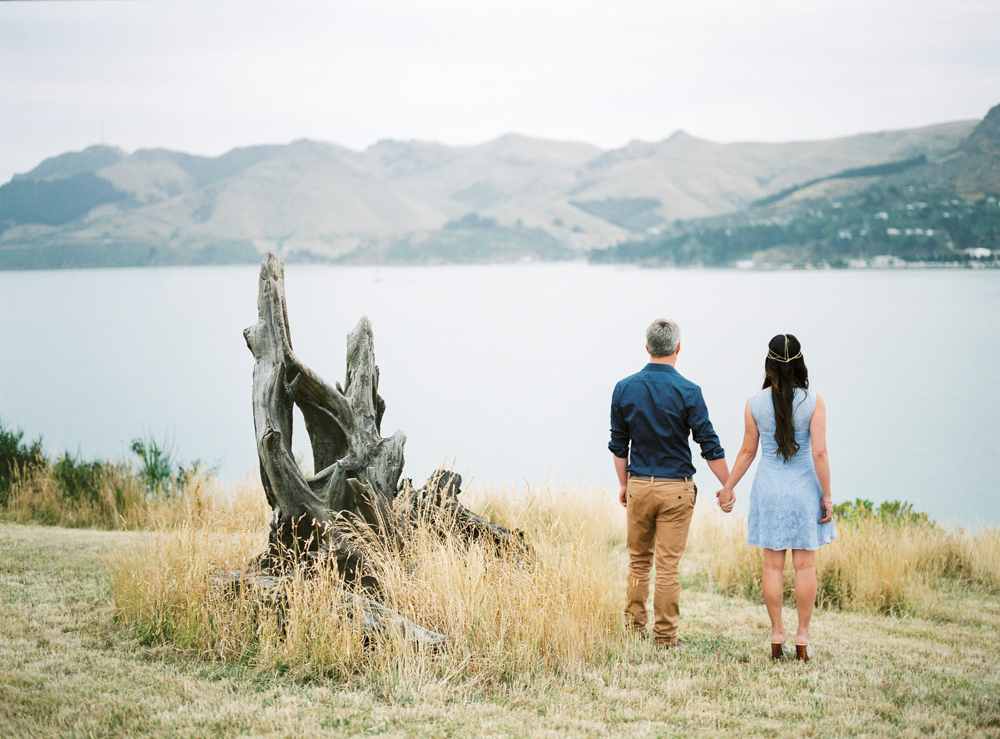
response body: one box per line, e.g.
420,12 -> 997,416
747,388 -> 837,551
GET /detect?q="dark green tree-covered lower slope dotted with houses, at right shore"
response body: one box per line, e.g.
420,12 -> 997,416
591,185 -> 1000,267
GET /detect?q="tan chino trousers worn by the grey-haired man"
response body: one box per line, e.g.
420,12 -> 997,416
626,477 -> 698,646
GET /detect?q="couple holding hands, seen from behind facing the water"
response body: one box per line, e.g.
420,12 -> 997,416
608,319 -> 836,660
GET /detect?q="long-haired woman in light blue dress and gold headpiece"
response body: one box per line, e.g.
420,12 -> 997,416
722,334 -> 836,661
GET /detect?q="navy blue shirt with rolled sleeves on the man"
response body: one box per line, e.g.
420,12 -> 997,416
608,362 -> 726,478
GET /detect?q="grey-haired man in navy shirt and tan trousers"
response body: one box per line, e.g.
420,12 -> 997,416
608,318 -> 735,647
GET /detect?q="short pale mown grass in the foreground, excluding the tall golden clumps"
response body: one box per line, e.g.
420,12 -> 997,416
0,494 -> 1000,737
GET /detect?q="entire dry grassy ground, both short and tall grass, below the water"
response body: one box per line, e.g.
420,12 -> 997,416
0,479 -> 1000,737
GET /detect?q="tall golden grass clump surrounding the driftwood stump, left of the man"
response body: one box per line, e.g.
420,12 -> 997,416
105,482 -> 626,695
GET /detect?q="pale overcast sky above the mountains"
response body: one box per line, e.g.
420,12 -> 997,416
0,0 -> 1000,181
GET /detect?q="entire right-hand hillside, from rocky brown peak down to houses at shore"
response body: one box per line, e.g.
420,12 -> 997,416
591,106 -> 1000,267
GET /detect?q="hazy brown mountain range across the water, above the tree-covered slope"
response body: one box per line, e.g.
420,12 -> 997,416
0,106 -> 1000,269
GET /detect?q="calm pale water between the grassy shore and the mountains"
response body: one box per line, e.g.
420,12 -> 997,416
0,264 -> 1000,524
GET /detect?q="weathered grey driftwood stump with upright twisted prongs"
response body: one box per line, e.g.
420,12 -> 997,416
237,254 -> 529,644
